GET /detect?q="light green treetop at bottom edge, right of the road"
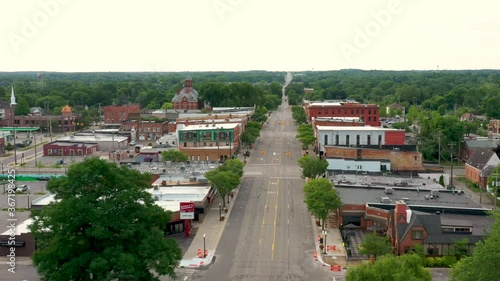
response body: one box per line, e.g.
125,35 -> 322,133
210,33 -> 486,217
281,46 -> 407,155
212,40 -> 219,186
346,254 -> 432,281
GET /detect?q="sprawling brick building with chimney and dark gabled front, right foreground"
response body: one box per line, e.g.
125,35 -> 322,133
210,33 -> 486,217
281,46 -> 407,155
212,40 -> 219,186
329,184 -> 493,256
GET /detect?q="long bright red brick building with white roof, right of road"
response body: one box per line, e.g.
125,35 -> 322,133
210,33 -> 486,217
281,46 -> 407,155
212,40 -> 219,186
304,100 -> 380,126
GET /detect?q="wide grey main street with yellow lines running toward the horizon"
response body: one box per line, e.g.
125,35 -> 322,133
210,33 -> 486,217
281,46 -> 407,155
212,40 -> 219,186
193,98 -> 332,281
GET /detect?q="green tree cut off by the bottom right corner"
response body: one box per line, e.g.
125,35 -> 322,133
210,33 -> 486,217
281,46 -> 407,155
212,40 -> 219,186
451,212 -> 500,281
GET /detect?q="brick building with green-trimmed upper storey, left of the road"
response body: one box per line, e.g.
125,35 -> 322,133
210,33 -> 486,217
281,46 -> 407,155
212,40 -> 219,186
177,123 -> 241,162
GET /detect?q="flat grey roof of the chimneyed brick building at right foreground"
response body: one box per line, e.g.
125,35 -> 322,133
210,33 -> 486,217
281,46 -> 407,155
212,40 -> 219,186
336,186 -> 482,208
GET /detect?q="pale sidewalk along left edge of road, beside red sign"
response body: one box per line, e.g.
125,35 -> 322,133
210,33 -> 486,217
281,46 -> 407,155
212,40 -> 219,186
179,188 -> 238,268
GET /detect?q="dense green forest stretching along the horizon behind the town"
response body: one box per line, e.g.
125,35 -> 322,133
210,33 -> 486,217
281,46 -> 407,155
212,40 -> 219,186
0,69 -> 500,161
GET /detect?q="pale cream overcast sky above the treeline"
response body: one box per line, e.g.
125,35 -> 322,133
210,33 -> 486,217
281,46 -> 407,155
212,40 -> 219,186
0,0 -> 500,72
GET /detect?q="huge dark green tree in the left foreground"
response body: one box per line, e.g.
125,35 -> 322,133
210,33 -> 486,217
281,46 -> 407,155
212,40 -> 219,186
30,157 -> 182,281
